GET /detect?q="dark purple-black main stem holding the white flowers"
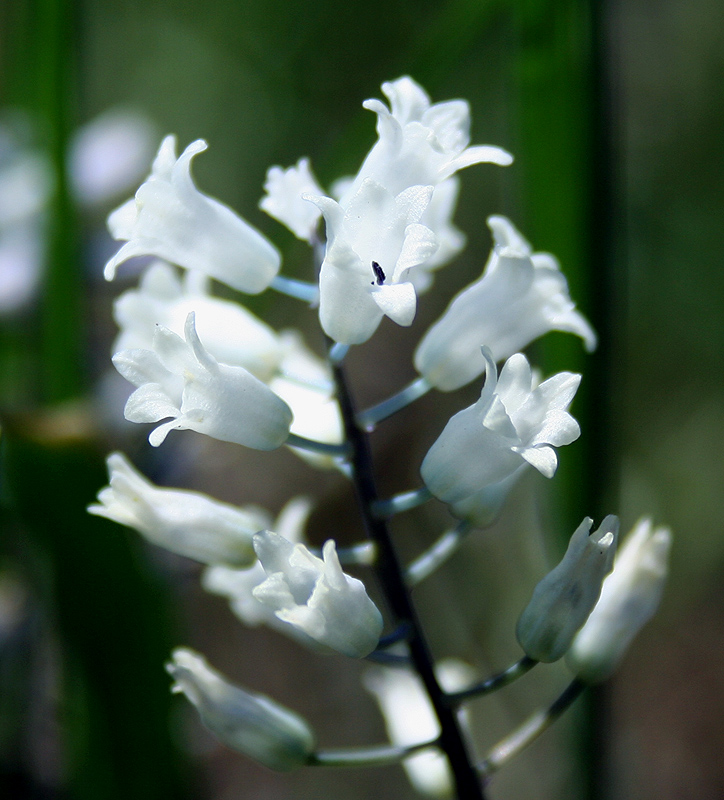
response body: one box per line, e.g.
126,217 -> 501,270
332,364 -> 485,800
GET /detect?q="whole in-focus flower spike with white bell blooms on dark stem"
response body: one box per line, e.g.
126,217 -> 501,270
89,77 -> 671,798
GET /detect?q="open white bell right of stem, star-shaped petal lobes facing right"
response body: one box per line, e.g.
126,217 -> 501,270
420,348 -> 581,504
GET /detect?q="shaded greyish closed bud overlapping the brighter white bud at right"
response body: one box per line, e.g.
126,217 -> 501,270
515,515 -> 619,662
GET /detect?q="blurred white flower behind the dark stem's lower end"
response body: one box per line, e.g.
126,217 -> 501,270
364,659 -> 474,797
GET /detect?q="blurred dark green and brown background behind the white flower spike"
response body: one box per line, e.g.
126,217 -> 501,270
0,0 -> 724,800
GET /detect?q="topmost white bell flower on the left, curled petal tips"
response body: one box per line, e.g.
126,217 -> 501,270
105,136 -> 281,294
